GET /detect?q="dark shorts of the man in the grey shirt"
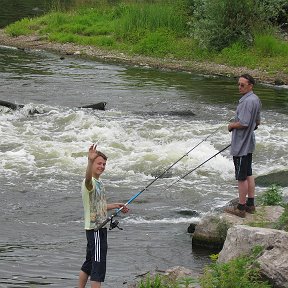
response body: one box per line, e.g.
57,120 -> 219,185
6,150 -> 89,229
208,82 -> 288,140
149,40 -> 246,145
233,153 -> 252,181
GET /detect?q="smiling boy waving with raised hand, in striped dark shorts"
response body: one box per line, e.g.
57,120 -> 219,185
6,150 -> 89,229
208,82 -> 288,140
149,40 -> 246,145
78,145 -> 129,288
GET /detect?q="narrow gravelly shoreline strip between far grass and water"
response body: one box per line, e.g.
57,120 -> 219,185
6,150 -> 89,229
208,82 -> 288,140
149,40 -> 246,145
0,30 -> 288,85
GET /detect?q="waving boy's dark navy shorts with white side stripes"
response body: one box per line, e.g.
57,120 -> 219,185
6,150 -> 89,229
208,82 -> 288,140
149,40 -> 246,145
81,228 -> 107,282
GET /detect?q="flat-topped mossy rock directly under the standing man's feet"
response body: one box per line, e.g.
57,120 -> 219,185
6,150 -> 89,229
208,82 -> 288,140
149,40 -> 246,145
192,206 -> 284,250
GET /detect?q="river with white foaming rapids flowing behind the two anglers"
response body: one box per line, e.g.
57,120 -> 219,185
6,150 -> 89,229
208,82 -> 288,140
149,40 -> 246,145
0,2 -> 288,288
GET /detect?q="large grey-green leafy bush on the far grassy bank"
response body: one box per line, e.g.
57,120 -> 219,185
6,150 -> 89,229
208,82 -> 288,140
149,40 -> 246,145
191,0 -> 286,51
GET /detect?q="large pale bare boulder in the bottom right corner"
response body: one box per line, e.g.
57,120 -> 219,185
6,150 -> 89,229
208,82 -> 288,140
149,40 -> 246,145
218,225 -> 288,288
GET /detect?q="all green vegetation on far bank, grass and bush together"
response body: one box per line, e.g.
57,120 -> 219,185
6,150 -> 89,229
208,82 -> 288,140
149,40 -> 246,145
5,0 -> 288,74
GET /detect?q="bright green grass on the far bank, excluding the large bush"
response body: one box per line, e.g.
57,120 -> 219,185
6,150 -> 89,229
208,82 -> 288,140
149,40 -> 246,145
5,0 -> 288,80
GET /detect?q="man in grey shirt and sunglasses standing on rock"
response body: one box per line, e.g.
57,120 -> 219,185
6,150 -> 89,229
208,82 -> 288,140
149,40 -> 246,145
225,74 -> 261,218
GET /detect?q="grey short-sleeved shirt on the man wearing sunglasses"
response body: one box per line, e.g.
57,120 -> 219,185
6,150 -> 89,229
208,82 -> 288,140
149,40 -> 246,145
230,91 -> 261,156
